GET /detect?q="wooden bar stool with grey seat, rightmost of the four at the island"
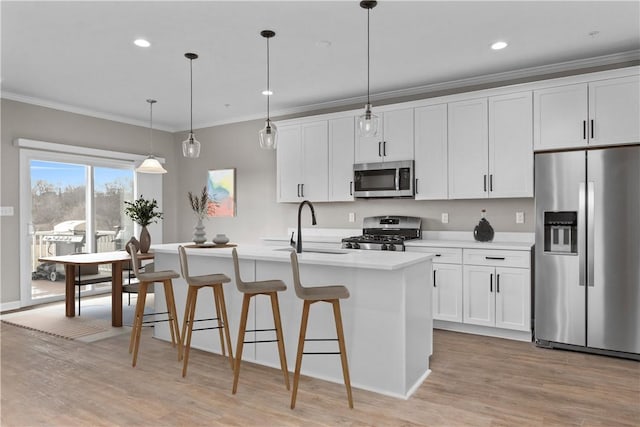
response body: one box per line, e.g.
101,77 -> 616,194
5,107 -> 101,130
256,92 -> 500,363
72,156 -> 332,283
291,251 -> 353,409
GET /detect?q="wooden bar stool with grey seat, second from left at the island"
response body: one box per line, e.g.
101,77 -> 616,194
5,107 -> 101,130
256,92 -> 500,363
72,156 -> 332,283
178,245 -> 233,377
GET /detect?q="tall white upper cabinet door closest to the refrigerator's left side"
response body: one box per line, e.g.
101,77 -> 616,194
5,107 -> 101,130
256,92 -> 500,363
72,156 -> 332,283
486,91 -> 533,198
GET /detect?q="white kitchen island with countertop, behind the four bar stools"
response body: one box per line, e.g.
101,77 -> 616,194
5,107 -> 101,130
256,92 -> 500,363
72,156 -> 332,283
153,243 -> 432,399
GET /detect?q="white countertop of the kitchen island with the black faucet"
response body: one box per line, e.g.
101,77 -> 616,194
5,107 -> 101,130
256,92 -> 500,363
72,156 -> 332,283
151,242 -> 433,270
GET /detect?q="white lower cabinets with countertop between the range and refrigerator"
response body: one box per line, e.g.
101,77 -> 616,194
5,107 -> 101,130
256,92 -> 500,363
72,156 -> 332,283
407,246 -> 531,339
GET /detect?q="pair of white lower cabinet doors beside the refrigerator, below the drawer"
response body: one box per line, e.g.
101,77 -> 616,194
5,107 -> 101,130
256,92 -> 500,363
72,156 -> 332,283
462,265 -> 531,331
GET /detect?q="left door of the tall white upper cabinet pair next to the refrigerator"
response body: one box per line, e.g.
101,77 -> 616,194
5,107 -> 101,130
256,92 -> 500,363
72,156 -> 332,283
448,98 -> 489,199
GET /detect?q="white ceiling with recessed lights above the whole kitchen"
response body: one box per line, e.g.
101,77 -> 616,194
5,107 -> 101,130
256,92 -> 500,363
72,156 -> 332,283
0,0 -> 640,131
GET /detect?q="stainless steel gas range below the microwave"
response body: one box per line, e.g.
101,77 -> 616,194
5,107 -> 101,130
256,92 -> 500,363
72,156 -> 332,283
342,216 -> 422,252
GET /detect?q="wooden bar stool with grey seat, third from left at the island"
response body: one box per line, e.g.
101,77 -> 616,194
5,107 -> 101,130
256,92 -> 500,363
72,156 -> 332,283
231,248 -> 289,394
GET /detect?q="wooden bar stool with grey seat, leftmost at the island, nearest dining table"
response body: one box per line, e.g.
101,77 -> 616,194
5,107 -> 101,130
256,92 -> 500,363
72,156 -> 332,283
128,243 -> 182,367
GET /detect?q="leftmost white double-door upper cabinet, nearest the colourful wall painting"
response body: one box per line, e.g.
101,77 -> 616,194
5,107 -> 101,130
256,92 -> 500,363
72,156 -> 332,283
277,120 -> 329,202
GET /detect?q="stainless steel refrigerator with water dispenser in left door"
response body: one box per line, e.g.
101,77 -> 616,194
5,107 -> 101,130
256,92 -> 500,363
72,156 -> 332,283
534,145 -> 640,360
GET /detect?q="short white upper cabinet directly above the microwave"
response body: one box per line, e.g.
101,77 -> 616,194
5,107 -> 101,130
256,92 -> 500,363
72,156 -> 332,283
355,108 -> 413,163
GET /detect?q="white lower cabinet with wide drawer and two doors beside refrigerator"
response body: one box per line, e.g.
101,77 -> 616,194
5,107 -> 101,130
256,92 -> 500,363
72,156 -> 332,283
462,250 -> 531,331
